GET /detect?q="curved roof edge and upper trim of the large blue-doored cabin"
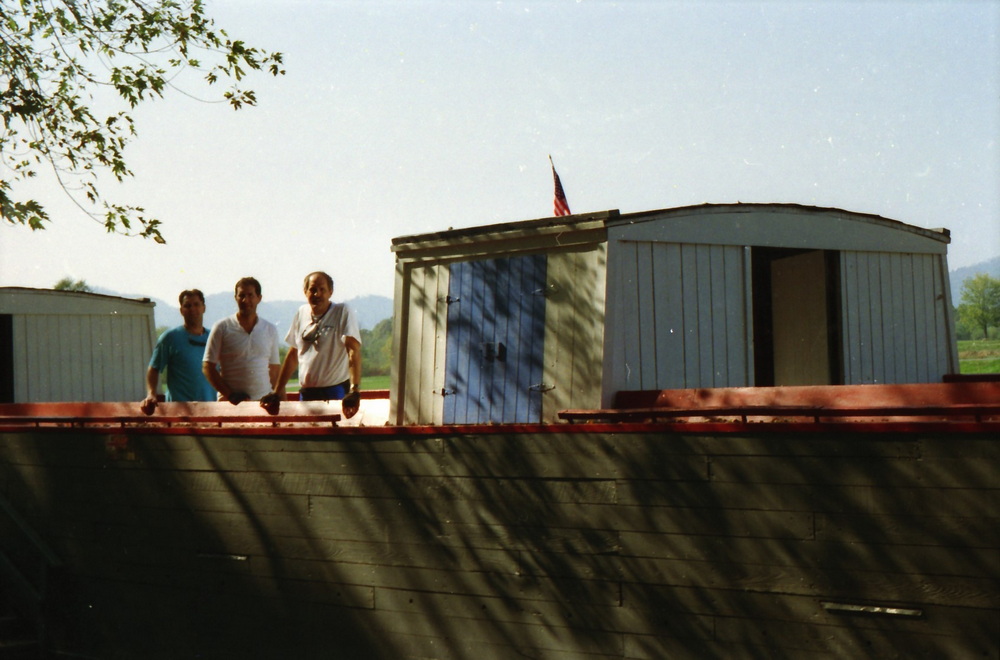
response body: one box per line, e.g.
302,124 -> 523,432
392,203 -> 951,260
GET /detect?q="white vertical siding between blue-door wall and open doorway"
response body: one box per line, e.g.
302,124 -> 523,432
603,241 -> 753,405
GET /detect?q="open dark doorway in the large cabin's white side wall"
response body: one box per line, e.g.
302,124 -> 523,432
751,247 -> 843,386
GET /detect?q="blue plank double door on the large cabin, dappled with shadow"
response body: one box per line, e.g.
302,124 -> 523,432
444,254 -> 546,424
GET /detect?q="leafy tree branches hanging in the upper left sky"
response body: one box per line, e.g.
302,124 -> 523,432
0,0 -> 284,243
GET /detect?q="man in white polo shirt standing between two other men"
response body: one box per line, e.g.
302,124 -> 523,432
201,277 -> 281,405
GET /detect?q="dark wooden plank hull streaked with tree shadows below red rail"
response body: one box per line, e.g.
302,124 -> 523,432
0,416 -> 1000,660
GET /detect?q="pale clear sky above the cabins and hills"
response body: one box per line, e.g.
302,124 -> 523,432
0,0 -> 1000,309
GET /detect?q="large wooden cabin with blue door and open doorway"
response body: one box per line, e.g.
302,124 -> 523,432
390,204 -> 958,424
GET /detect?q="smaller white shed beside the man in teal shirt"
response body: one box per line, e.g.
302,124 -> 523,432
0,287 -> 156,403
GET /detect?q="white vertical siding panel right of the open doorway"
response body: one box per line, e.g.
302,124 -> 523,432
841,252 -> 957,384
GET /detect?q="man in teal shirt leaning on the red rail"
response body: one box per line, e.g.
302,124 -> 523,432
141,289 -> 216,415
